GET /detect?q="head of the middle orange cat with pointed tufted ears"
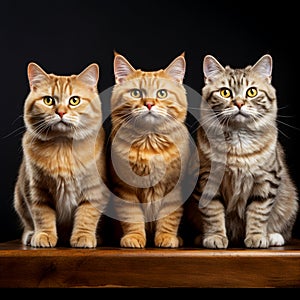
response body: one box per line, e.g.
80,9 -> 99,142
111,52 -> 187,131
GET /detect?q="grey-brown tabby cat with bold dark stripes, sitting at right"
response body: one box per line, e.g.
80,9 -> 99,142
186,55 -> 298,248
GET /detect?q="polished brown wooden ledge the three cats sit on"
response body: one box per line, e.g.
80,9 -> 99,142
0,240 -> 300,288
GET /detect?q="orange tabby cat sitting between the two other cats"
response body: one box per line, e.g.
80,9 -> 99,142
110,53 -> 189,248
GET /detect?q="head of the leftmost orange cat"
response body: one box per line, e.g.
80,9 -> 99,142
24,62 -> 102,140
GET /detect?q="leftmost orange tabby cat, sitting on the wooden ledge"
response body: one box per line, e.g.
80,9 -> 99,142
14,63 -> 106,248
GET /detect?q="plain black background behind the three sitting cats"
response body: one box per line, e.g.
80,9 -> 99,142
0,0 -> 300,242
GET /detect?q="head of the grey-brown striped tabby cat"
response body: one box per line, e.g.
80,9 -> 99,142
202,54 -> 277,128
